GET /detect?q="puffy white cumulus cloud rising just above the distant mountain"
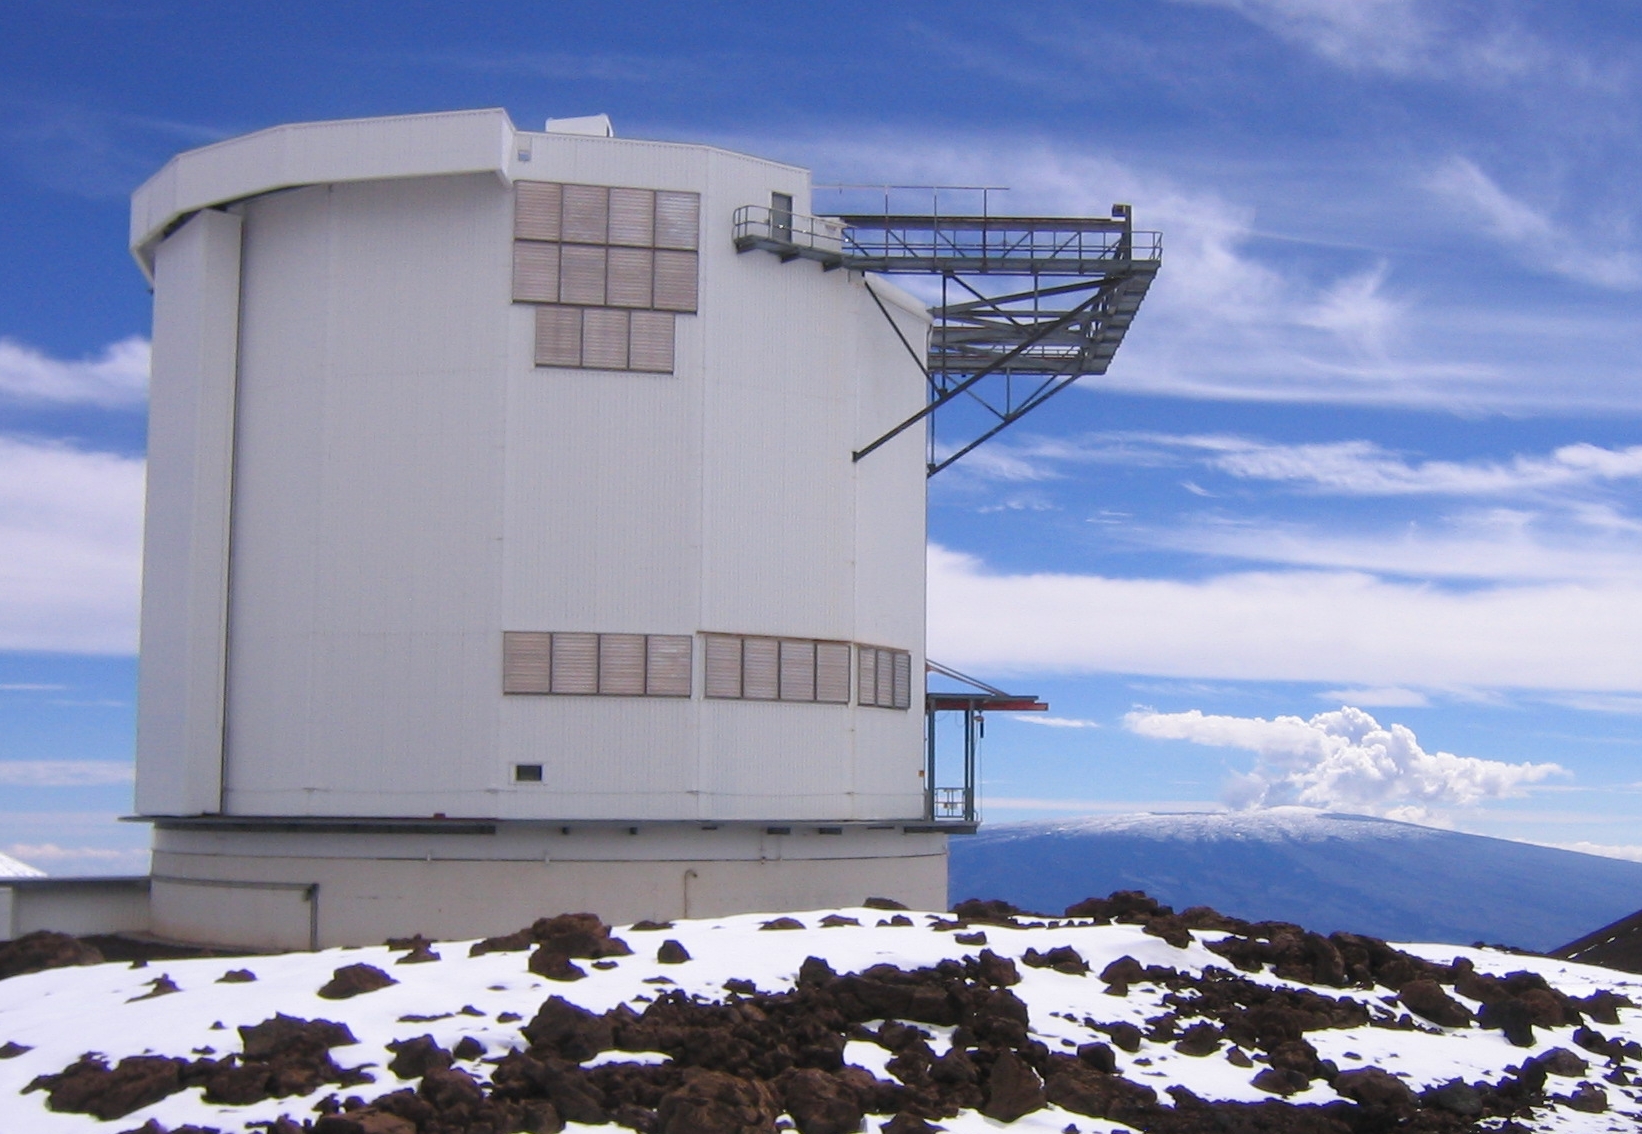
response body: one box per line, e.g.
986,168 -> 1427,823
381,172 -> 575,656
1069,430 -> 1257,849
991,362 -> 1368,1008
1123,706 -> 1566,819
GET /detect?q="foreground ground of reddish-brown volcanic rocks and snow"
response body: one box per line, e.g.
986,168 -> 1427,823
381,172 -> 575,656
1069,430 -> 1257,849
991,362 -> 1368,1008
0,893 -> 1642,1134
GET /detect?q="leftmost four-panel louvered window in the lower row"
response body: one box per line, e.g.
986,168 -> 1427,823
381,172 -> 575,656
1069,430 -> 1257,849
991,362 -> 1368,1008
502,630 -> 695,697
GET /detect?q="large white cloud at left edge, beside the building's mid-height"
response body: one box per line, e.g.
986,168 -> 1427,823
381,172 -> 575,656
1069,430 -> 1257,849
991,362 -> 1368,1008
0,437 -> 143,653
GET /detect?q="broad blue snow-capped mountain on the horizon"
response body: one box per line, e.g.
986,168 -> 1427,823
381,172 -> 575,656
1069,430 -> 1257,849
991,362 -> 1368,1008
951,807 -> 1642,950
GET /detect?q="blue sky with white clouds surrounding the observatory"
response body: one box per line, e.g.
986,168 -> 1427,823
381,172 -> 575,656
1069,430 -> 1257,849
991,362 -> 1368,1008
0,0 -> 1642,873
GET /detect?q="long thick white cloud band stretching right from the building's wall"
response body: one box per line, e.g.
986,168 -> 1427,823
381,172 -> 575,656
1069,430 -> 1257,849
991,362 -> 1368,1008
929,545 -> 1642,693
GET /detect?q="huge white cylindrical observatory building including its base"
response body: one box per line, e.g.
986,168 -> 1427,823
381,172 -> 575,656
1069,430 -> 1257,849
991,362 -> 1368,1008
131,110 -> 946,947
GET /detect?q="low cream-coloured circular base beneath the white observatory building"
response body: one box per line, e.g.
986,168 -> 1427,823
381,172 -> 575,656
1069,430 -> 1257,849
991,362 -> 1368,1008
151,822 -> 946,949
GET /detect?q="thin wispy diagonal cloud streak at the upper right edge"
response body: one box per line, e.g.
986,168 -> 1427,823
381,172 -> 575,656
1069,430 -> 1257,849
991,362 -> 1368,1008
1425,158 -> 1642,289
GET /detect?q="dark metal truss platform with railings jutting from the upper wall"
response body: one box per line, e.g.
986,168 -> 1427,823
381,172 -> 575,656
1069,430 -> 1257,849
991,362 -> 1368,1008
736,205 -> 1163,476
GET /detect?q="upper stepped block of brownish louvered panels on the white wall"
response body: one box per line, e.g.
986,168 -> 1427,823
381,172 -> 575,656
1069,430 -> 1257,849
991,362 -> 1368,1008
512,181 -> 701,374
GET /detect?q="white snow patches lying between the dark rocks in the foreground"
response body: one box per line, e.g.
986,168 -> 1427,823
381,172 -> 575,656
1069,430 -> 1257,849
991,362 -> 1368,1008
0,909 -> 1642,1134
